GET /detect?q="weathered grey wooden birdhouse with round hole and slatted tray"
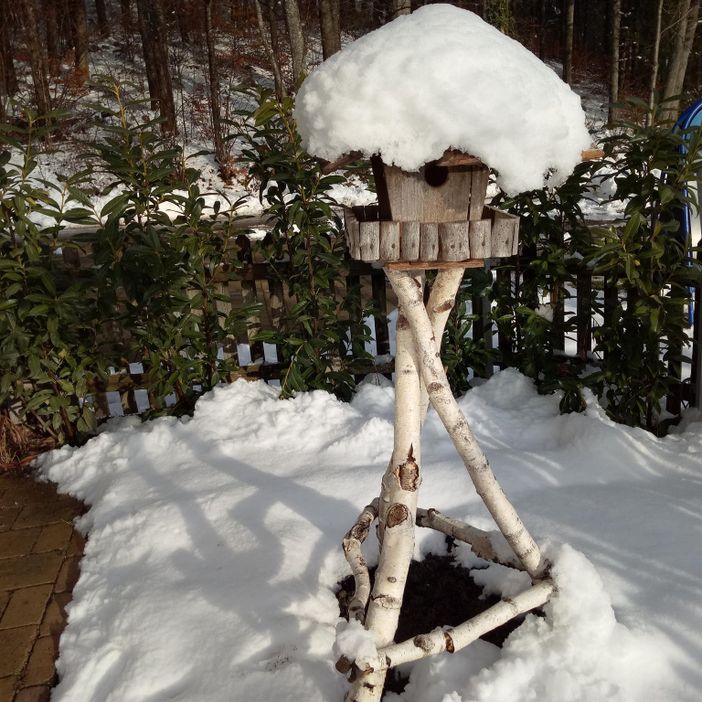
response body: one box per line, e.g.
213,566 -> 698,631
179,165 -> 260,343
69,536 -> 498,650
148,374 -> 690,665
345,151 -> 519,267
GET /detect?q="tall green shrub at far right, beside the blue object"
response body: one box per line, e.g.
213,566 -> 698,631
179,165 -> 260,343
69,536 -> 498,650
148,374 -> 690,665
588,118 -> 702,430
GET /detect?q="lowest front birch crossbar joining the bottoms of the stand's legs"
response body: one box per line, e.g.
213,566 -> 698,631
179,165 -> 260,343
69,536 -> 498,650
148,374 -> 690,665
355,579 -> 555,671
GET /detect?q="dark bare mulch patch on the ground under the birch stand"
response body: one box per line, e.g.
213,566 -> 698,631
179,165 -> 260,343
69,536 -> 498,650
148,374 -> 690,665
337,553 -> 524,693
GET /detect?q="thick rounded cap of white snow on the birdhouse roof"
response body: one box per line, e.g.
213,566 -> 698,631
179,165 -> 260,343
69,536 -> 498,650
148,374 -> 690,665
295,4 -> 590,194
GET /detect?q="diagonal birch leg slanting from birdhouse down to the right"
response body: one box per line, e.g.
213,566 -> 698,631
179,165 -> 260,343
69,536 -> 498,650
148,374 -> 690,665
385,269 -> 546,579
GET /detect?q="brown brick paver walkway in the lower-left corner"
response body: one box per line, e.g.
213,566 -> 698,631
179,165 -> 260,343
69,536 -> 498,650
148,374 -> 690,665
0,474 -> 84,702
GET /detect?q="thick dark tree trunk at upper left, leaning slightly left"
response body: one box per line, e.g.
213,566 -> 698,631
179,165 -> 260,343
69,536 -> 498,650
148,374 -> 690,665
137,0 -> 176,134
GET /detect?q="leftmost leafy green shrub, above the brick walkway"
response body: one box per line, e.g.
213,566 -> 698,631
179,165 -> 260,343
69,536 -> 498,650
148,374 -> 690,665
0,115 -> 101,452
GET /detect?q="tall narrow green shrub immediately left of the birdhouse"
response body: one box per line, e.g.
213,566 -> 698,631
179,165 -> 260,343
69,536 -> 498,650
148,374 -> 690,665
244,92 -> 369,399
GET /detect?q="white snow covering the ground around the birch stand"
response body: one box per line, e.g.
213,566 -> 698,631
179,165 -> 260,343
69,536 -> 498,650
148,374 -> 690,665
40,370 -> 702,702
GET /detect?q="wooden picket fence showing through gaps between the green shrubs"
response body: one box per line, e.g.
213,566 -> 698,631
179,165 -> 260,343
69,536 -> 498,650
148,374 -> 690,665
57,219 -> 702,417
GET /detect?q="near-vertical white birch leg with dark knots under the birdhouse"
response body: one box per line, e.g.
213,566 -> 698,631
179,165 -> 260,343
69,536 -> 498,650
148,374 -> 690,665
346,275 -> 422,702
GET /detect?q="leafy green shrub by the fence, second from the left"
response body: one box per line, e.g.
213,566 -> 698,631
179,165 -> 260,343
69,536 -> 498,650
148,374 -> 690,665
84,83 -> 250,413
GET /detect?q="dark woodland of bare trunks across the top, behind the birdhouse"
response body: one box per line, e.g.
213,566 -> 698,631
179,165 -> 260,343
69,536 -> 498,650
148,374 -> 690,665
0,0 -> 702,155
